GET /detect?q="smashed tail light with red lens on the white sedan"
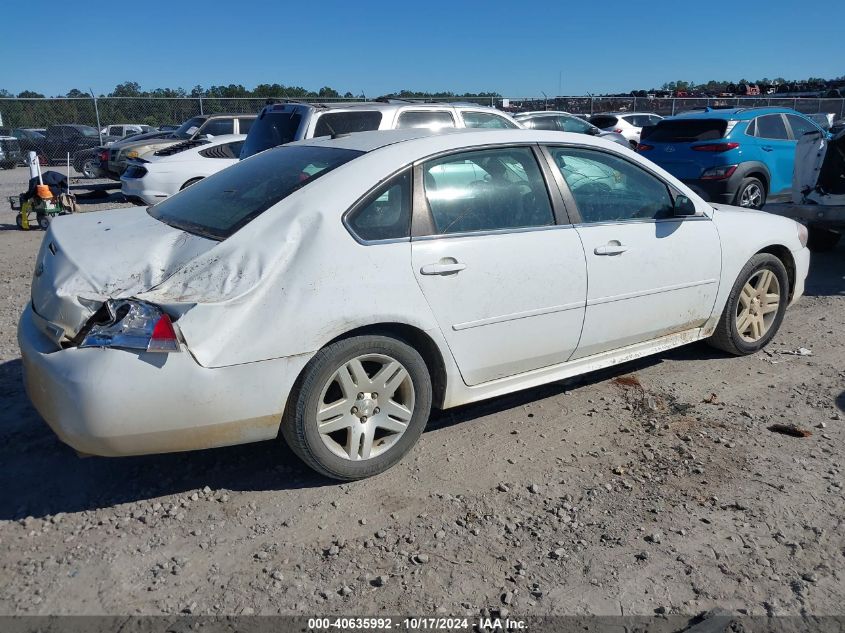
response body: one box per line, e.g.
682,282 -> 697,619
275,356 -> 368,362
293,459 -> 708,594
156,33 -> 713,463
79,299 -> 179,352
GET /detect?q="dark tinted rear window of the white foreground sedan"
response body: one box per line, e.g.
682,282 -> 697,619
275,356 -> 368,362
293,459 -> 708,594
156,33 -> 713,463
147,145 -> 363,240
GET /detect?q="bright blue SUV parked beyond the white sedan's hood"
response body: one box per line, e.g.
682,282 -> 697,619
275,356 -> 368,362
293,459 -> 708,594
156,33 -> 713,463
637,108 -> 824,209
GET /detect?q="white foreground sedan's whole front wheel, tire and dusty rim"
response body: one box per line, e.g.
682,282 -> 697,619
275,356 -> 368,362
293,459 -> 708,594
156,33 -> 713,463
707,253 -> 789,356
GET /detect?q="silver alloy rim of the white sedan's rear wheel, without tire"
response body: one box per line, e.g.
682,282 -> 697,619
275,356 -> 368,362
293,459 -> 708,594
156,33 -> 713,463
316,354 -> 415,461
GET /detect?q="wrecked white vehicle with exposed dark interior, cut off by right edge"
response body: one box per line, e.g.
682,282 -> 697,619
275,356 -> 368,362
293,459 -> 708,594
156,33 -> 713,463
763,130 -> 845,252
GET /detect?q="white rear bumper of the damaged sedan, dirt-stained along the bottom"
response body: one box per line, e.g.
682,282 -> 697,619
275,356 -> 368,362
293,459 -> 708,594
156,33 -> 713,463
18,307 -> 308,456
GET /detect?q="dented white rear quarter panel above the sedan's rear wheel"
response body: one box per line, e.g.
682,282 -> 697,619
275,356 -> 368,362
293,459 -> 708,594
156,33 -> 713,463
137,147 -> 448,367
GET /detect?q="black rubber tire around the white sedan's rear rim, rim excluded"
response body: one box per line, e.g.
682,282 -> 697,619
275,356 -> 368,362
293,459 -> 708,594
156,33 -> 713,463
282,335 -> 431,481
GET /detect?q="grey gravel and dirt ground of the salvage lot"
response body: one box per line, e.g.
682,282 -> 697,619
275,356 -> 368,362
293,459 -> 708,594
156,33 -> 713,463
0,164 -> 845,615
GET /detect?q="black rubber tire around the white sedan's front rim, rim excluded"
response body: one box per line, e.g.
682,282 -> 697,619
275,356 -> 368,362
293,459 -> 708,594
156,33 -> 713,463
707,253 -> 789,356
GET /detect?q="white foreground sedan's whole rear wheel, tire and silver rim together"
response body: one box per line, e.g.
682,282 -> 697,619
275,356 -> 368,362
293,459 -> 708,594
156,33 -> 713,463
282,336 -> 431,480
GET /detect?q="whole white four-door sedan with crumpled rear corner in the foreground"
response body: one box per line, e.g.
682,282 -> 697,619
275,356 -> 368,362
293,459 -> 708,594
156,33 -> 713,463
18,130 -> 809,479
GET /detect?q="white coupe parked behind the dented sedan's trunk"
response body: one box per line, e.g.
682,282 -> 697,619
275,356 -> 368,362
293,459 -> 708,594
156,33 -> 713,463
120,134 -> 246,204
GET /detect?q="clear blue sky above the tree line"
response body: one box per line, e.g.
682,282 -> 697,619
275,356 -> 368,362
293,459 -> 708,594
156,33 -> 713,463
0,0 -> 845,97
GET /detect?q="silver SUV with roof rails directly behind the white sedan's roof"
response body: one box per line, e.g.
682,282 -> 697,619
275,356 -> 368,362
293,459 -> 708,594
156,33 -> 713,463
241,100 -> 522,160
